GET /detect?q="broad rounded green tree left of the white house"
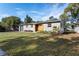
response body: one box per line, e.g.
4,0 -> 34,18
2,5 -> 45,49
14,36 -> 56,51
2,16 -> 21,31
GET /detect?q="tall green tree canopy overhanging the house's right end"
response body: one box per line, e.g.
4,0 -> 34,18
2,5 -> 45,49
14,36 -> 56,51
60,3 -> 79,29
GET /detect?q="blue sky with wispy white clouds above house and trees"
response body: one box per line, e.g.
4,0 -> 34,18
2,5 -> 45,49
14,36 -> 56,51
0,3 -> 68,21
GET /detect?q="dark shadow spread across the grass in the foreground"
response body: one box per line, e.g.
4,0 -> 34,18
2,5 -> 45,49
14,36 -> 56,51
0,36 -> 79,56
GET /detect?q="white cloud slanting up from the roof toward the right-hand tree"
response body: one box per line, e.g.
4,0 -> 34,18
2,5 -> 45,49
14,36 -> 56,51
41,4 -> 66,21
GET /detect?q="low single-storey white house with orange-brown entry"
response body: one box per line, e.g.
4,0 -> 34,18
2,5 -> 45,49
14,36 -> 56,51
19,20 -> 61,32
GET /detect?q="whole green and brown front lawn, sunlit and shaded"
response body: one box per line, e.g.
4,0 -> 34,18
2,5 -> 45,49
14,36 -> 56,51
0,32 -> 79,56
